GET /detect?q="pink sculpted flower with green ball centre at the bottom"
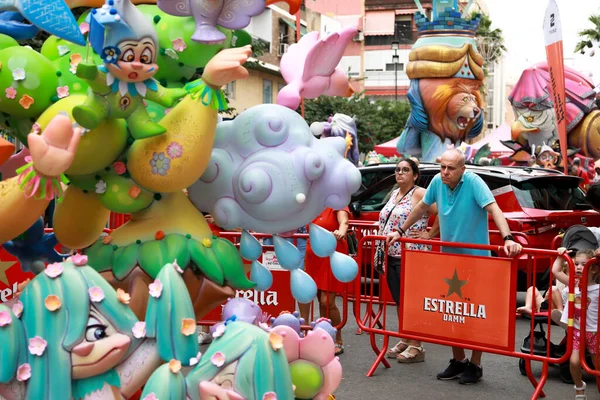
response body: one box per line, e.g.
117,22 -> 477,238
271,325 -> 342,400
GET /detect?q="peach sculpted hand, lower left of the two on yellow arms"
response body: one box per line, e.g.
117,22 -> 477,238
27,115 -> 81,177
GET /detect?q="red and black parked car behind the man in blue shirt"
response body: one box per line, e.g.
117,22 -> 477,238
350,163 -> 600,289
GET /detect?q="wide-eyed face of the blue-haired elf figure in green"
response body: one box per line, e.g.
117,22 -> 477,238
106,38 -> 158,82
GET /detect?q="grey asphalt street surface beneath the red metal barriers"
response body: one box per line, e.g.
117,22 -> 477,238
335,304 -> 600,400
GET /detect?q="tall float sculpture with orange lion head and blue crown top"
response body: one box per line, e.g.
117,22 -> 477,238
397,0 -> 484,162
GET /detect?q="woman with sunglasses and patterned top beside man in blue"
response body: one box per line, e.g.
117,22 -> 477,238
379,158 -> 439,363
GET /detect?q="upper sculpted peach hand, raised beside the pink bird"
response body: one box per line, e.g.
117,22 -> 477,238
202,45 -> 252,88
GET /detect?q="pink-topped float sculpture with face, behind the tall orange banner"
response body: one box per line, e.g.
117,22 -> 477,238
502,61 -> 600,166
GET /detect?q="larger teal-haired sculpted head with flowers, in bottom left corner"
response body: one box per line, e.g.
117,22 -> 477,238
0,255 -> 198,400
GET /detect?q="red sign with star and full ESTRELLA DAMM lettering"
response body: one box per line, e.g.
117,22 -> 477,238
400,250 -> 516,350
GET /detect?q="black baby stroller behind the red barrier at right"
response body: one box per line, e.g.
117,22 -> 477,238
519,225 -> 598,384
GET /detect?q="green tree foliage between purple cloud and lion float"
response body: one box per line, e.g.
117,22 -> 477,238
304,93 -> 410,152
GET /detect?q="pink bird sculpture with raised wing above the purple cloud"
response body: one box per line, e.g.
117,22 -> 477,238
277,27 -> 357,110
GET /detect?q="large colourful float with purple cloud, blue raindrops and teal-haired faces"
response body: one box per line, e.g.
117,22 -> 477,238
0,0 -> 360,400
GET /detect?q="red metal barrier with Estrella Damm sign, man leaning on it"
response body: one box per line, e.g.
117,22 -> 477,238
354,236 -> 574,398
